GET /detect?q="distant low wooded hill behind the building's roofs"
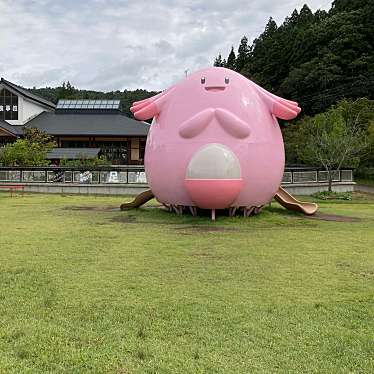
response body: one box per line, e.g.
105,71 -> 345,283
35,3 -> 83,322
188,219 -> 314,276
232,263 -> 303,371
29,82 -> 157,117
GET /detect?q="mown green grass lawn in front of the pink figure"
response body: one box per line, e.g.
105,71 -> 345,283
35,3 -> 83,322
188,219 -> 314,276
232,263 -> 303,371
0,193 -> 374,374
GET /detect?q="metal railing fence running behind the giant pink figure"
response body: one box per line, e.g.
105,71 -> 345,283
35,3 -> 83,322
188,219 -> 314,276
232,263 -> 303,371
0,166 -> 353,185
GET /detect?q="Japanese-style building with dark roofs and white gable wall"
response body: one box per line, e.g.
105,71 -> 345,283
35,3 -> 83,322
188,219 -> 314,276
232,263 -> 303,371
0,78 -> 149,165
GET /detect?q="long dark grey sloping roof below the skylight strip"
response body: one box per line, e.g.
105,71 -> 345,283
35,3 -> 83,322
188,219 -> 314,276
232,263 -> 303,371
26,112 -> 150,136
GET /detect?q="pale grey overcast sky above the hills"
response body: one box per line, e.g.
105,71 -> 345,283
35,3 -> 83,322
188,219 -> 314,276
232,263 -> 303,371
0,0 -> 331,91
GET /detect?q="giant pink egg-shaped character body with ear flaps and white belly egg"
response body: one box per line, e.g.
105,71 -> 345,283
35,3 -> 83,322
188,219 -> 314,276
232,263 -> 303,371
131,68 -> 300,209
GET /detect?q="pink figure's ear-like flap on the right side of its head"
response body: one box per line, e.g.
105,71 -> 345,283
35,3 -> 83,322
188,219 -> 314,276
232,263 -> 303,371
251,82 -> 301,120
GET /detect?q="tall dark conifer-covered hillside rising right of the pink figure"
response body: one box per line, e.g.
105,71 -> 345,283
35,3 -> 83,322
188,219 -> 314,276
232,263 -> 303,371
214,0 -> 374,114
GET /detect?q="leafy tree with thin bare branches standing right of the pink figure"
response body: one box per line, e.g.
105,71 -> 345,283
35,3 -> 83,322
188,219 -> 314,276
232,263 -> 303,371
298,103 -> 368,191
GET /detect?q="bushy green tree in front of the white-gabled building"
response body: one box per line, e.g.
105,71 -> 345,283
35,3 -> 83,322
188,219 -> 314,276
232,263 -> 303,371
0,128 -> 55,166
